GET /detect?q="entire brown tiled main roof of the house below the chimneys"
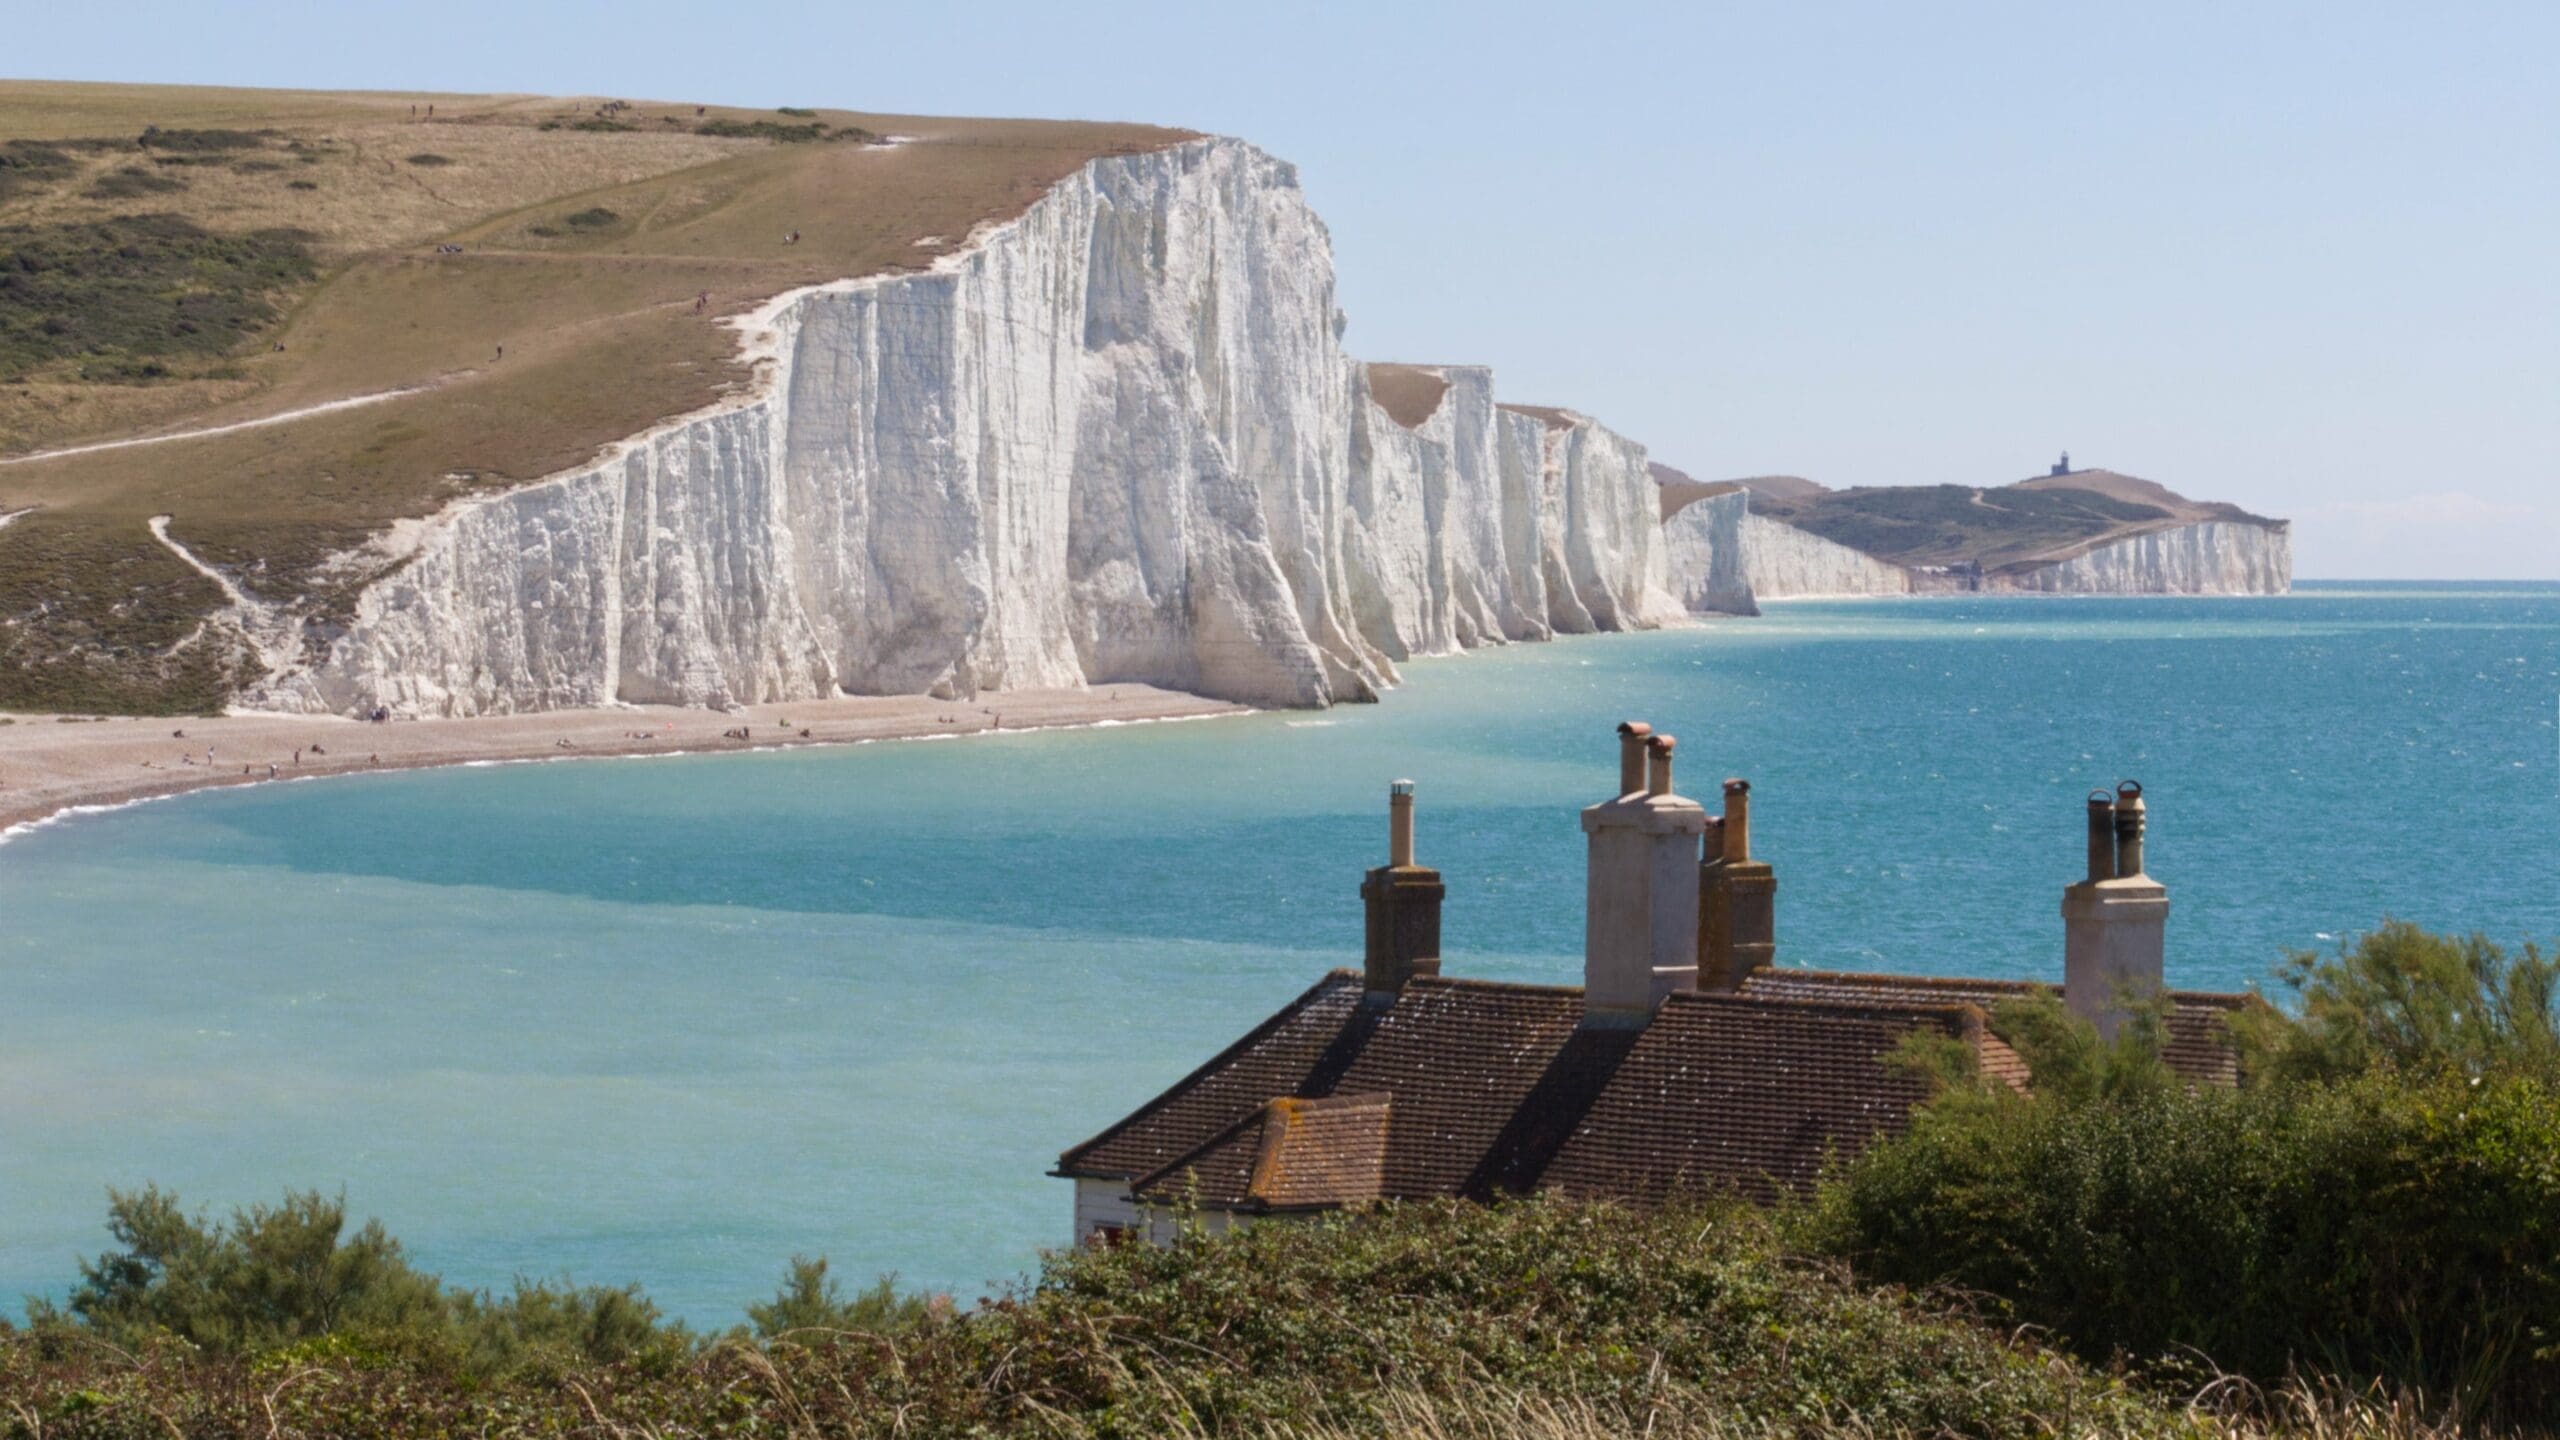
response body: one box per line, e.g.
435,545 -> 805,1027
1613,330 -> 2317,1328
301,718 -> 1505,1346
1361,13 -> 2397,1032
1057,969 -> 2248,1212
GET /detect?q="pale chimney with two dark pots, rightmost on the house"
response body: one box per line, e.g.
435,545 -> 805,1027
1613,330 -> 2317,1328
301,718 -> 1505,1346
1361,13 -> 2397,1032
2063,779 -> 2168,1040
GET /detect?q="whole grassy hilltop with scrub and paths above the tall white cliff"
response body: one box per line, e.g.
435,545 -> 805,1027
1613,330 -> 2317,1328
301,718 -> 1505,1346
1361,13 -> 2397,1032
0,82 -> 1185,712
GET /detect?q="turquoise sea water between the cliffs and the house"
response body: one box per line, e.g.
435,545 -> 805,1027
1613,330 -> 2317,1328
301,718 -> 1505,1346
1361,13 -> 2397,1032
0,576 -> 2560,1325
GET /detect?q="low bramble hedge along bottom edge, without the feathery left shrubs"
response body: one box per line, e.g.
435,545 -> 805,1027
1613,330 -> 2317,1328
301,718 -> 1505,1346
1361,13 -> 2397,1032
0,1202 -> 2214,1437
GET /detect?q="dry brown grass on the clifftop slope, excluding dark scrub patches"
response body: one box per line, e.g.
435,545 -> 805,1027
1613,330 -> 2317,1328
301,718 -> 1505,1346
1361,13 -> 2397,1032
0,82 -> 1188,707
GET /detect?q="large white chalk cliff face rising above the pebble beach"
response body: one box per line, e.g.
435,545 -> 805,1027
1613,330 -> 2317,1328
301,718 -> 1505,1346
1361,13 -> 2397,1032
251,141 -> 1679,715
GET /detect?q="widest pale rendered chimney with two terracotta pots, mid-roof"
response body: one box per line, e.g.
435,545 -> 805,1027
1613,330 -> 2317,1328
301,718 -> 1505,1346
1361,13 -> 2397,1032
1582,720 -> 1708,1027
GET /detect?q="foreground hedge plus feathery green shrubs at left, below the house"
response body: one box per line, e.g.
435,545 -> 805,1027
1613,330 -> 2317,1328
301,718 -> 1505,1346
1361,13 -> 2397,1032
0,1191 -> 2207,1437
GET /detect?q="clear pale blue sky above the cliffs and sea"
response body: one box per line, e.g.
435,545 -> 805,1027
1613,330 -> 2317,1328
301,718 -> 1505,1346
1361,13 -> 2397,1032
0,0 -> 2560,579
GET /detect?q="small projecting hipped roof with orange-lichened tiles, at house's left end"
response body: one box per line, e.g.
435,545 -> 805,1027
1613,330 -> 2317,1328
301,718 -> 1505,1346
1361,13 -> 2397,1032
1129,1094 -> 1395,1209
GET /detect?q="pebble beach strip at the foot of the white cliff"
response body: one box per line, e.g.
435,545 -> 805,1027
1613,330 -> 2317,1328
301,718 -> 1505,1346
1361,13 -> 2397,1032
0,684 -> 1252,843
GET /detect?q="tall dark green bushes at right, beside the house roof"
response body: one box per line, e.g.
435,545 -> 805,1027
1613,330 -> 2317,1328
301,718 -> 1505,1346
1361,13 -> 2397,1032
1810,925 -> 2560,1427
